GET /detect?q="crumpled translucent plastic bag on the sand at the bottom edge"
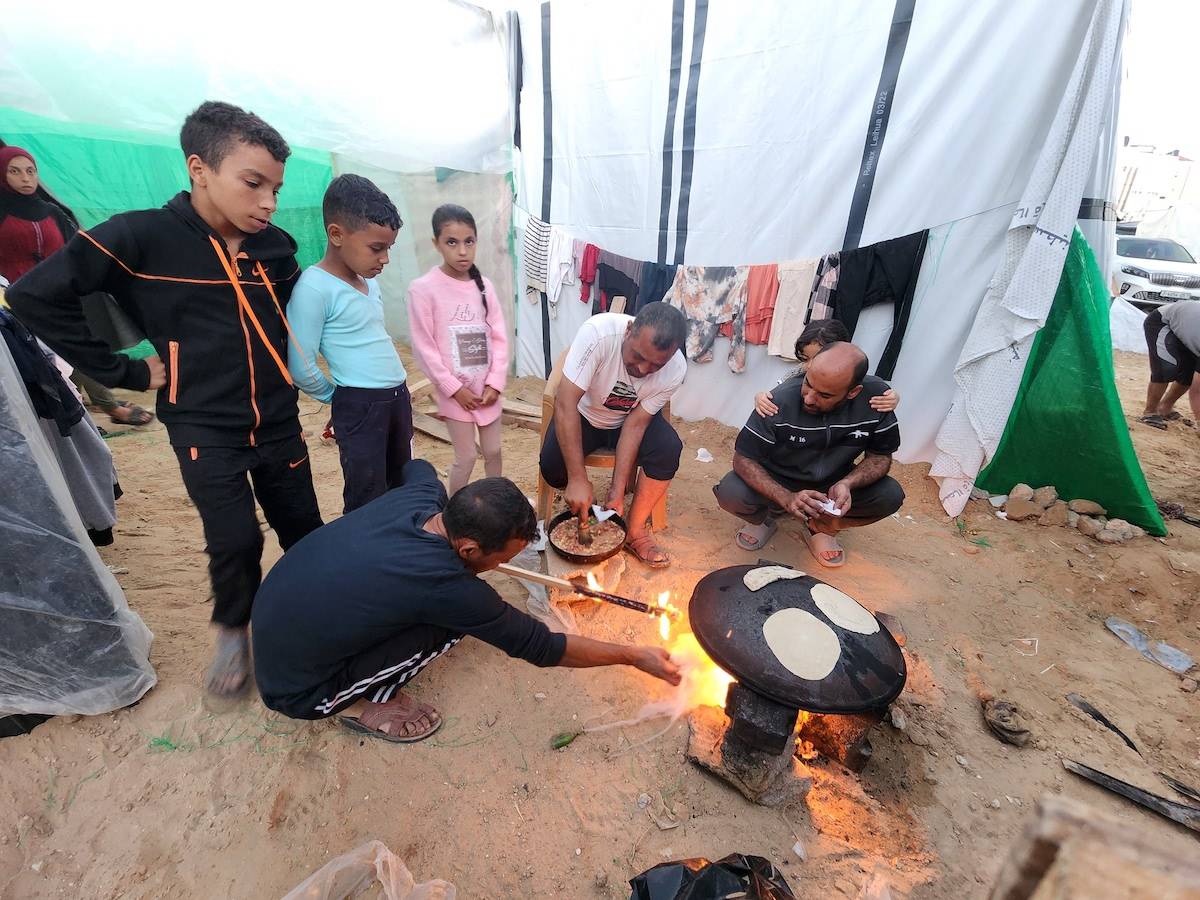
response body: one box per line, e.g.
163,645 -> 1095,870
283,841 -> 457,900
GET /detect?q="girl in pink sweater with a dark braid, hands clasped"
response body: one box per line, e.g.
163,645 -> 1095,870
408,204 -> 509,496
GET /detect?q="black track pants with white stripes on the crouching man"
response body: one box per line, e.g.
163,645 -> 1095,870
263,625 -> 462,719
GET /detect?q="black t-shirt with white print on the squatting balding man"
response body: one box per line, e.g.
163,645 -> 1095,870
734,376 -> 900,491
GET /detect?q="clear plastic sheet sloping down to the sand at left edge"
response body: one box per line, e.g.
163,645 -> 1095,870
0,342 -> 156,715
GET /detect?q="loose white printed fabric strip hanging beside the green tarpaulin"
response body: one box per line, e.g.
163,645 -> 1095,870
930,1 -> 1126,515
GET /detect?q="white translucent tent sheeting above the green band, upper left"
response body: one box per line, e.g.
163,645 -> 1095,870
0,0 -> 512,173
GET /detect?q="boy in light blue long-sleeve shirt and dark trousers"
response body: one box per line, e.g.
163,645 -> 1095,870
288,175 -> 413,512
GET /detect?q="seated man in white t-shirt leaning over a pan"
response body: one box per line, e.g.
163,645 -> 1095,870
540,302 -> 688,569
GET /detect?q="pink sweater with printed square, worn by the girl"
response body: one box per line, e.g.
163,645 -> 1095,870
408,266 -> 509,425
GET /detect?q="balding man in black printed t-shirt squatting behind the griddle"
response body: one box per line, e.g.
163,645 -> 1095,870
713,342 -> 904,569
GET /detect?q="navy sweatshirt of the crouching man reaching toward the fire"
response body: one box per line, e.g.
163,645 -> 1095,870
252,460 -> 566,706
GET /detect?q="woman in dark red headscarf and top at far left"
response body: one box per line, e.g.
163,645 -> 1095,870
0,146 -> 154,425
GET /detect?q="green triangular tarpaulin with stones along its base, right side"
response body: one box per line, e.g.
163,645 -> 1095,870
976,228 -> 1166,535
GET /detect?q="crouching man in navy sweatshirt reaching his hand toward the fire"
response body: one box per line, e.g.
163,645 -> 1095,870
253,460 -> 679,743
